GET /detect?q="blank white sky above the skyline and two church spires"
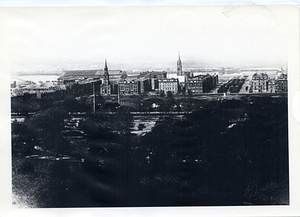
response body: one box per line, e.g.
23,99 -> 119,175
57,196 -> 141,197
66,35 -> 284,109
2,5 -> 289,72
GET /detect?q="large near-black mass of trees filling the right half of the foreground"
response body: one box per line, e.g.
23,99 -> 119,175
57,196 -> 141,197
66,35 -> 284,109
126,98 -> 289,206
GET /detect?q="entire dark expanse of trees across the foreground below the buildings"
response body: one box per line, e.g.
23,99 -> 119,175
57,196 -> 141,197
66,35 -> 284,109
12,95 -> 289,207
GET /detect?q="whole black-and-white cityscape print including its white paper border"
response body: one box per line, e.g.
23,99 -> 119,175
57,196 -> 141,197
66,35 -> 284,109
1,4 -> 299,215
